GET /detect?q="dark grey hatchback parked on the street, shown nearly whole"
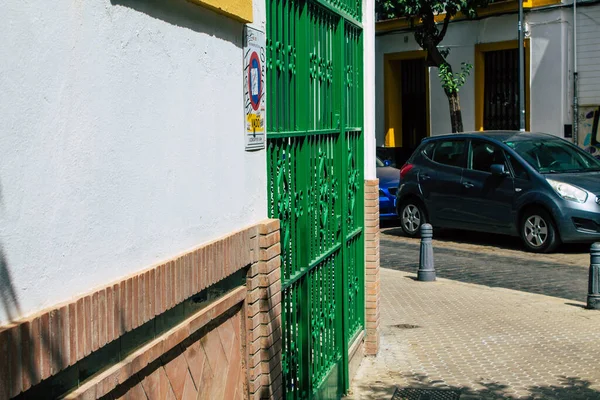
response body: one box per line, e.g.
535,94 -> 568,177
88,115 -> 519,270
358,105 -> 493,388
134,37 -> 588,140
396,132 -> 600,252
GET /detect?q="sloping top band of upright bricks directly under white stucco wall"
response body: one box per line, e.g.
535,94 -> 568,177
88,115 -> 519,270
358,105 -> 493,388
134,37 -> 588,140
0,220 -> 264,399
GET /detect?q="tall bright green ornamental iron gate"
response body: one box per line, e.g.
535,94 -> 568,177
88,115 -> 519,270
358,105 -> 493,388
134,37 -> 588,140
266,0 -> 364,399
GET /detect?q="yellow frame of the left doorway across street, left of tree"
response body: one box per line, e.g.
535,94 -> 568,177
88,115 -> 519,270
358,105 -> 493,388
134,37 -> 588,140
383,50 -> 431,147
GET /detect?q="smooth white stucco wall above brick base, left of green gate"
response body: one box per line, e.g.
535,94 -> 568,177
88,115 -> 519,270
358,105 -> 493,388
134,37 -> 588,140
0,0 -> 267,324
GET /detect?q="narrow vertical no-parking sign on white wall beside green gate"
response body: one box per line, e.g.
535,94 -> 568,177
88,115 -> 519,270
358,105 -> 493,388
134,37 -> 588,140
243,26 -> 266,151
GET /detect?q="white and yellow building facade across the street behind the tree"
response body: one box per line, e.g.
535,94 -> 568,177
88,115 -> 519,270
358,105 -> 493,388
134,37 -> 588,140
376,1 -> 600,160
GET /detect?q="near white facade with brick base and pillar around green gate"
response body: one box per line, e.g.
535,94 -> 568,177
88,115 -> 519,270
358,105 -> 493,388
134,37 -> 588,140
0,0 -> 379,400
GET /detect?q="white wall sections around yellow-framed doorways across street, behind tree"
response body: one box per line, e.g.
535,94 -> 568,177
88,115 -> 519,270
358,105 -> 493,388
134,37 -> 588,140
376,10 -> 570,146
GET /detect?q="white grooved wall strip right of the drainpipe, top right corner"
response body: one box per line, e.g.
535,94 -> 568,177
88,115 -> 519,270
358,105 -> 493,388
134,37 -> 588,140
577,5 -> 600,106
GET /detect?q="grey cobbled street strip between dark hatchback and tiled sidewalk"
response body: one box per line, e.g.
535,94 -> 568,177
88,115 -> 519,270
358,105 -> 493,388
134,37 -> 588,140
380,229 -> 589,301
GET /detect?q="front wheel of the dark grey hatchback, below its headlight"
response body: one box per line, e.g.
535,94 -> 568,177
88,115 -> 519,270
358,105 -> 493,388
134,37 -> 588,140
519,209 -> 560,253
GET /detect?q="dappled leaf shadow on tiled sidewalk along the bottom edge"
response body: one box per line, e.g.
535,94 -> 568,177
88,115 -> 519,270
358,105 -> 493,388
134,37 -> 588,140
350,373 -> 600,400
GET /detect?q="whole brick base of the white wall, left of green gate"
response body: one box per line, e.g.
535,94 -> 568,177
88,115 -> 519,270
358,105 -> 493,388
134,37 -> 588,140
0,220 -> 282,400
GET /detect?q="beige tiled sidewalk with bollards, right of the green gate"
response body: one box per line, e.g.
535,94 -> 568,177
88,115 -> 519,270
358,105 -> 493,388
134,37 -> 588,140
348,268 -> 600,400
